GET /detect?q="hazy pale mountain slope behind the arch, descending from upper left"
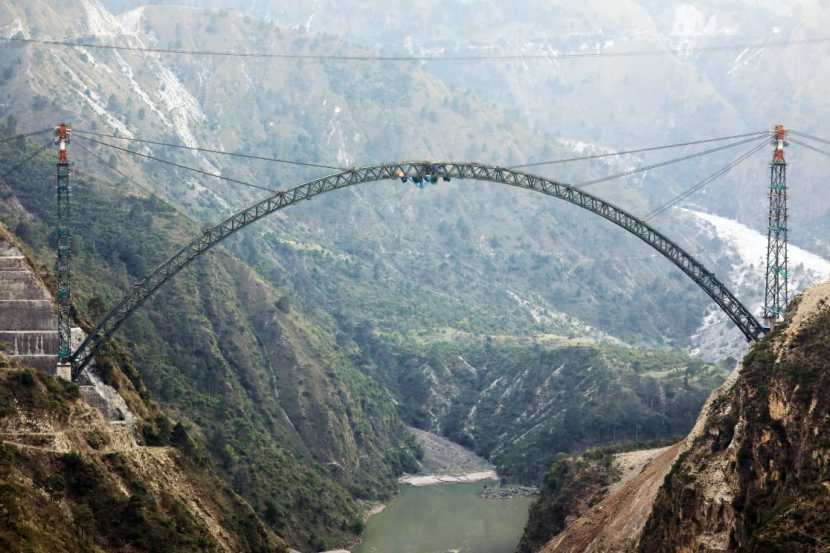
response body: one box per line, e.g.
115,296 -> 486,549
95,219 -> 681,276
0,0 -> 736,350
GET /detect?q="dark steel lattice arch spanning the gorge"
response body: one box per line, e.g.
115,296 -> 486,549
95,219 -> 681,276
70,161 -> 767,378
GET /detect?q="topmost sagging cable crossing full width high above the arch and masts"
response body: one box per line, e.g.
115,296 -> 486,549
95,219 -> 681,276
0,37 -> 830,63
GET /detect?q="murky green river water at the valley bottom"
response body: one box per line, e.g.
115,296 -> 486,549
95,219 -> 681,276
354,482 -> 533,553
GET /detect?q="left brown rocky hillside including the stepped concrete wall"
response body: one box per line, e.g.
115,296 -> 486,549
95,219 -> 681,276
0,225 -> 286,553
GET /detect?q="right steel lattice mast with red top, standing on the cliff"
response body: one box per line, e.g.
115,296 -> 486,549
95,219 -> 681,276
764,125 -> 789,328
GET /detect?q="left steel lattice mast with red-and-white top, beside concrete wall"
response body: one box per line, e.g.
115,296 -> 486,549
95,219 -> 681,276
55,123 -> 72,374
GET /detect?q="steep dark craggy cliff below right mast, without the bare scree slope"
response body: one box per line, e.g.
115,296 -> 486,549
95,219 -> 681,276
639,284 -> 830,553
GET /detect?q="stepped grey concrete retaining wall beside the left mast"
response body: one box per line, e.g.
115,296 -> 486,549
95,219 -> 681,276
0,238 -> 58,374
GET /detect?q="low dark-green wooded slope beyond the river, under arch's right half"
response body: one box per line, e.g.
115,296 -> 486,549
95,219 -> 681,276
350,334 -> 727,484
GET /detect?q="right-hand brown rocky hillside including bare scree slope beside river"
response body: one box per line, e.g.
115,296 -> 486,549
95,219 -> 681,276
521,284 -> 830,553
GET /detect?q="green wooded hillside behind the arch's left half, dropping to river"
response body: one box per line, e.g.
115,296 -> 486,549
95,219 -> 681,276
0,135 -> 415,549
